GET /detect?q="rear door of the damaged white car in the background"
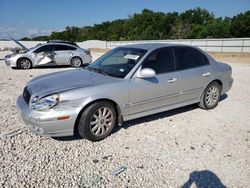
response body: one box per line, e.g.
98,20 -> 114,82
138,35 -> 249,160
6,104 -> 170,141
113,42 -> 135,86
54,44 -> 72,65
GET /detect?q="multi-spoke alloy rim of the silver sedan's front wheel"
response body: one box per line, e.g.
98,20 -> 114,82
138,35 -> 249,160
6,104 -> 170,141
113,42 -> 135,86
90,107 -> 114,136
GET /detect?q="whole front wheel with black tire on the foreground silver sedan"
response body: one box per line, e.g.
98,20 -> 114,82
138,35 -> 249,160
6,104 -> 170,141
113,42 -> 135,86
78,101 -> 117,141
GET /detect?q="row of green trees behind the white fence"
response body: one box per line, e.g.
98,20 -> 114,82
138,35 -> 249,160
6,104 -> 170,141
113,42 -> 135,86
21,7 -> 250,42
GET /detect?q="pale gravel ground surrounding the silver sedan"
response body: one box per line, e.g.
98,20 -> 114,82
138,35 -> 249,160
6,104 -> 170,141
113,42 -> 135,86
0,52 -> 250,187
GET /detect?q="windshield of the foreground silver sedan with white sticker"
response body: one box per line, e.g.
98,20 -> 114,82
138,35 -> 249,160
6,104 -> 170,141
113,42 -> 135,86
86,47 -> 147,78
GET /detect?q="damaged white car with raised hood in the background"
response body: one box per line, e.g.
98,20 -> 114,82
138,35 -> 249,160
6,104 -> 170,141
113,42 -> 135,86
5,39 -> 92,69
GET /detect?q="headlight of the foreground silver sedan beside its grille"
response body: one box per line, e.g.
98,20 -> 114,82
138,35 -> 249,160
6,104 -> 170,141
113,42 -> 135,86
30,94 -> 59,110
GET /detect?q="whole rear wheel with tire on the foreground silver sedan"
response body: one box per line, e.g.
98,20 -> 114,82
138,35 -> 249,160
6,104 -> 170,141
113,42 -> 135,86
199,82 -> 222,110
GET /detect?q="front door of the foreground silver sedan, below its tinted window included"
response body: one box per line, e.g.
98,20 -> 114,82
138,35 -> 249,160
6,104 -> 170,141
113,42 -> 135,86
129,48 -> 179,114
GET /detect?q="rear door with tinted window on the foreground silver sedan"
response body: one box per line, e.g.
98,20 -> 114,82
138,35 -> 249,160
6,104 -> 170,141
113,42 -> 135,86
173,46 -> 212,103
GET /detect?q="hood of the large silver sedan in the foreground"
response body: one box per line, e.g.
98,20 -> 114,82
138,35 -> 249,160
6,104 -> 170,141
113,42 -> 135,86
27,69 -> 120,97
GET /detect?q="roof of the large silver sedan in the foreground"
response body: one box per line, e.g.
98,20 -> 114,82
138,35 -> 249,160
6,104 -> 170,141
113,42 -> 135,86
121,43 -> 193,50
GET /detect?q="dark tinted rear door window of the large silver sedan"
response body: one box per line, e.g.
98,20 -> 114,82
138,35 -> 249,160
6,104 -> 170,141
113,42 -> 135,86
174,47 -> 207,70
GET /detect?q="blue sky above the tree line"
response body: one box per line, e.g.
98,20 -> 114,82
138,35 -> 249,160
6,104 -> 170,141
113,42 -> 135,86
0,0 -> 250,39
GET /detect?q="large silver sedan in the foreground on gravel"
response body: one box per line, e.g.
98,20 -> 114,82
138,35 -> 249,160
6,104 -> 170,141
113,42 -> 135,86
17,44 -> 233,141
